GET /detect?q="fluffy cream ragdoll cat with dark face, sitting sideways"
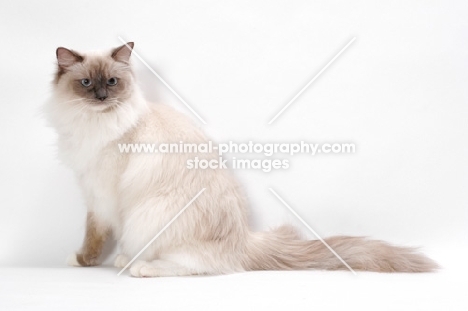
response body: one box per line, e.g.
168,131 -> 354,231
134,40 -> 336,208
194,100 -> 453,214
46,42 -> 437,277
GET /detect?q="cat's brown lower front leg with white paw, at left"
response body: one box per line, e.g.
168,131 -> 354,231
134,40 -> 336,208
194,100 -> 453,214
67,212 -> 109,267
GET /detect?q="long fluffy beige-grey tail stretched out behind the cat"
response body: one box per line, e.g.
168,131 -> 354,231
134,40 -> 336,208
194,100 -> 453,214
245,226 -> 438,272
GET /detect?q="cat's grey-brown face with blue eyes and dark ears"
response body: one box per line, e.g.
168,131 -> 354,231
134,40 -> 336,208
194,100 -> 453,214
55,42 -> 133,112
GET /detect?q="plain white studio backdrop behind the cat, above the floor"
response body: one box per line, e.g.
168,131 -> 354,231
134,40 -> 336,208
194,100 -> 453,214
0,0 -> 468,310
